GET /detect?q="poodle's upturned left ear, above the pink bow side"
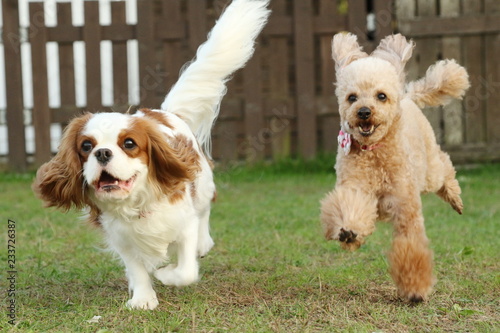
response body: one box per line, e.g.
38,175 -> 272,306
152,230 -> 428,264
332,33 -> 368,73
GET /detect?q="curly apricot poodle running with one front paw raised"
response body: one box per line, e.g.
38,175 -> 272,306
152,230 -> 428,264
321,34 -> 469,302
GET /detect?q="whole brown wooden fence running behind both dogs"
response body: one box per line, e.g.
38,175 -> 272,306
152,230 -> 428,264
2,0 -> 500,170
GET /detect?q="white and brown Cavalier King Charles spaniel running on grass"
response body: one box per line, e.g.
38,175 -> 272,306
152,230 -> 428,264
33,0 -> 270,310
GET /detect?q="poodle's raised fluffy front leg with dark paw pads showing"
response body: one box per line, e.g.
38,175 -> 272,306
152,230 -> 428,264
321,186 -> 377,251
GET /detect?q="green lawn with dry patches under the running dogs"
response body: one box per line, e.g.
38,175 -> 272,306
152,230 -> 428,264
0,159 -> 500,332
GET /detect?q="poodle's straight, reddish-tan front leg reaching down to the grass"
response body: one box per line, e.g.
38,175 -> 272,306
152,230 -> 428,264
388,193 -> 435,302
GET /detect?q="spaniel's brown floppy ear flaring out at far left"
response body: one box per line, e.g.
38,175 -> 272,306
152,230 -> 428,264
31,113 -> 92,211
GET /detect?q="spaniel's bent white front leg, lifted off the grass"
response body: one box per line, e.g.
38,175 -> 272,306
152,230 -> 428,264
154,218 -> 199,287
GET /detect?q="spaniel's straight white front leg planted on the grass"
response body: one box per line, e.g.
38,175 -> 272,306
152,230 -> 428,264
119,252 -> 158,310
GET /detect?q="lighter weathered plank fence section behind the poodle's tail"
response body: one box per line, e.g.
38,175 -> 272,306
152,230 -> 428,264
396,0 -> 500,162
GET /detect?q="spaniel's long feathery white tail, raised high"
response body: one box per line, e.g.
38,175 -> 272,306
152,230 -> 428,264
161,0 -> 270,154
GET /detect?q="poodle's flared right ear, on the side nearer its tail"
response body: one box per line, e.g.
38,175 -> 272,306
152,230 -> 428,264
371,34 -> 415,82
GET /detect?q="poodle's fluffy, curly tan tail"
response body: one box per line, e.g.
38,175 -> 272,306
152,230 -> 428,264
406,60 -> 470,108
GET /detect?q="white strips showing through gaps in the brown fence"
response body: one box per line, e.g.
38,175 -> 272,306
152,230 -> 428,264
0,0 -> 139,156
